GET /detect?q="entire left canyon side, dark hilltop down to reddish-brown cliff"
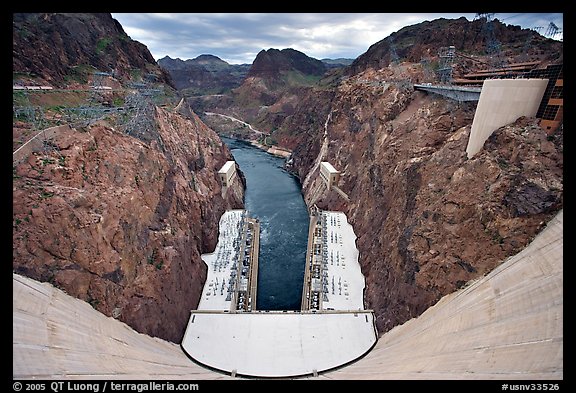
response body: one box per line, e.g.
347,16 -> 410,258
12,10 -> 244,342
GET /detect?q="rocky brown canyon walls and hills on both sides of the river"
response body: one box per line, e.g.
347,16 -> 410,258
13,10 -> 563,360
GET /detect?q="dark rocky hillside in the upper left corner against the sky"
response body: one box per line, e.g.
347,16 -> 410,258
12,13 -> 171,87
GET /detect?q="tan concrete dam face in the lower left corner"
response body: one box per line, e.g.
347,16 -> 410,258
12,274 -> 231,380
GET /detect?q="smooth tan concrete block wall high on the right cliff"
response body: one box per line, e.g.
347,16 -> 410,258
466,79 -> 548,158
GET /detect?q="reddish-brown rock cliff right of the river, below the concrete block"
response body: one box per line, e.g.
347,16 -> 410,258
283,63 -> 563,332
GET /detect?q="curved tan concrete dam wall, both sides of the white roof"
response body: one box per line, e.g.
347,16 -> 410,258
12,211 -> 563,379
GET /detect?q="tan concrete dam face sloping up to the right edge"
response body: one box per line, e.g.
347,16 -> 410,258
320,212 -> 564,379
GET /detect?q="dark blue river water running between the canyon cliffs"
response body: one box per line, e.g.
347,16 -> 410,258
222,137 -> 309,310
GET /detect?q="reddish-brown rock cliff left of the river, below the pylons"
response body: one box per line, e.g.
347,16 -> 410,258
13,103 -> 244,343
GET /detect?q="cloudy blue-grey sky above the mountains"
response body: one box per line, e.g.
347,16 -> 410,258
112,13 -> 563,64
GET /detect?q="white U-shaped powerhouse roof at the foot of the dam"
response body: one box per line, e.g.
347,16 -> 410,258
181,210 -> 377,377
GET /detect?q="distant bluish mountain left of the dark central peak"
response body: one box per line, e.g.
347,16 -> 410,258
158,55 -> 250,95
